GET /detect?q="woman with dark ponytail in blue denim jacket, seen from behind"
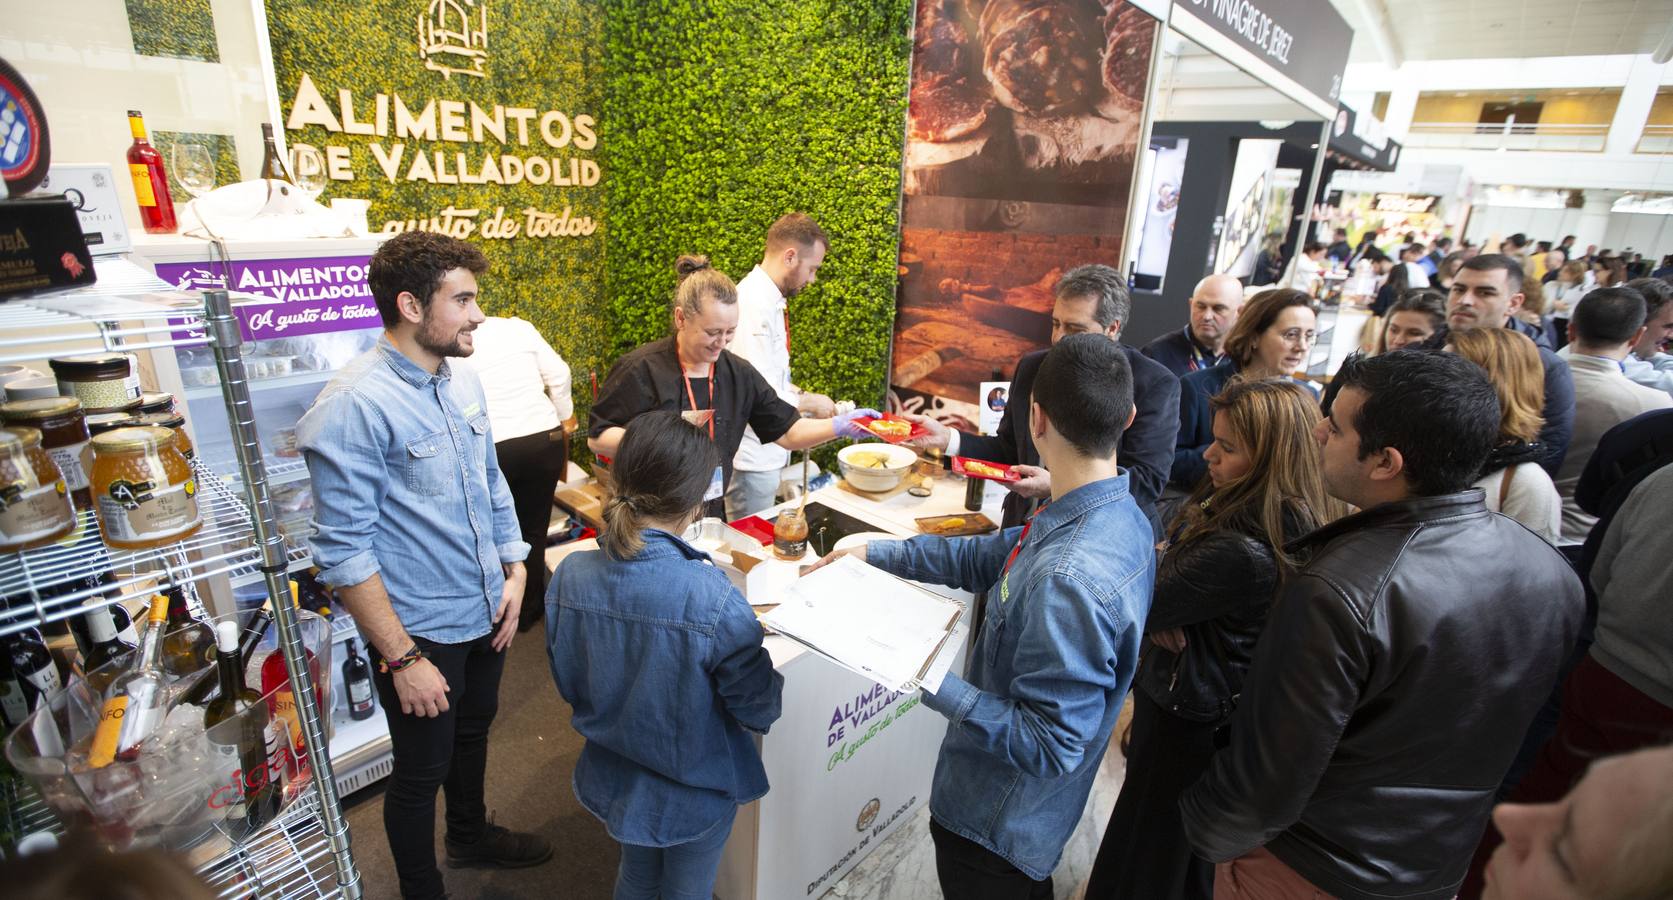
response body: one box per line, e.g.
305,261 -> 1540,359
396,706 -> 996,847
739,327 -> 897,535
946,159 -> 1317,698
545,412 -> 785,900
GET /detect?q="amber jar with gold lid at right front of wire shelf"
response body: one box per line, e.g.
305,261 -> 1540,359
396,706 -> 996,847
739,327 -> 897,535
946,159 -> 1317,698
92,425 -> 202,550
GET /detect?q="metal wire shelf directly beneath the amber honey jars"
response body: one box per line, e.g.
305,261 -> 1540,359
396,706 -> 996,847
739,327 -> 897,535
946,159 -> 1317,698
0,465 -> 308,637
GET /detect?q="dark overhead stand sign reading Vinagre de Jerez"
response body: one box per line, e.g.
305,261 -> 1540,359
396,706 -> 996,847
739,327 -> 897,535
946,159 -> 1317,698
1168,0 -> 1353,119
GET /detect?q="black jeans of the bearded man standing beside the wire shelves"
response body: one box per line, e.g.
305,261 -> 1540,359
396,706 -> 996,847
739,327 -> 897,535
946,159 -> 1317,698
368,632 -> 505,900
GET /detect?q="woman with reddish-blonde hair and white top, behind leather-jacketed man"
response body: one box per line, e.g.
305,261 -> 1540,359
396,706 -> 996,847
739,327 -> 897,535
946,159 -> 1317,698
1447,328 -> 1563,544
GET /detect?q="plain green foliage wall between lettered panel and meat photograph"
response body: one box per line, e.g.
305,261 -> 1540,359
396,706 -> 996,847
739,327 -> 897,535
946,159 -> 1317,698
601,0 -> 912,405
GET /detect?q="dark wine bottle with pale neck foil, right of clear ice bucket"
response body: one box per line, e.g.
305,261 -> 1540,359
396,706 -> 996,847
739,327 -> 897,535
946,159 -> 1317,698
204,622 -> 284,830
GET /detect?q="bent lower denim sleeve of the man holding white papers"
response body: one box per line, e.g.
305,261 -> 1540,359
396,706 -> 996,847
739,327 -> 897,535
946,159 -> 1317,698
923,572 -> 1118,778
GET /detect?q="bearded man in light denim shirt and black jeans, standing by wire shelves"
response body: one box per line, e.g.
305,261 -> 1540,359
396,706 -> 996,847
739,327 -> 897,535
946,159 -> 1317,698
296,231 -> 552,900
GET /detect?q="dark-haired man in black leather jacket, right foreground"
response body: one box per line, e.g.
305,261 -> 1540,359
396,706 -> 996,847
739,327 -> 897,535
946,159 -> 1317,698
1179,350 -> 1584,900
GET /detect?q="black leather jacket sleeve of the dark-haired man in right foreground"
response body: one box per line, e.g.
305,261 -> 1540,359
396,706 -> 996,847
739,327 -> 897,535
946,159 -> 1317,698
1179,574 -> 1372,863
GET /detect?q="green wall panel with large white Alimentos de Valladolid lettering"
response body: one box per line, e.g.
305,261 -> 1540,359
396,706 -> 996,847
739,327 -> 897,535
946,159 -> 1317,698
267,0 -> 609,400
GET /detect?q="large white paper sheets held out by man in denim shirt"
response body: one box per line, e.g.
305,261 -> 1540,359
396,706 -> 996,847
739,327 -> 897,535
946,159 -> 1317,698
761,555 -> 965,691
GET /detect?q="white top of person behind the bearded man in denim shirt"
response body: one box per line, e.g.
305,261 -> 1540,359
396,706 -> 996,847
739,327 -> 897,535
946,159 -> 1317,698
452,316 -> 576,442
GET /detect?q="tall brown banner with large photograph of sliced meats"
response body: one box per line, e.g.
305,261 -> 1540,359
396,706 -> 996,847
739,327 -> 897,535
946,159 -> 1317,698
890,0 -> 1158,423
